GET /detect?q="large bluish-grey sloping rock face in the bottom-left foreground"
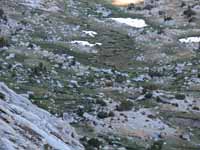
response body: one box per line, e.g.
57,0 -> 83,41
0,83 -> 83,150
